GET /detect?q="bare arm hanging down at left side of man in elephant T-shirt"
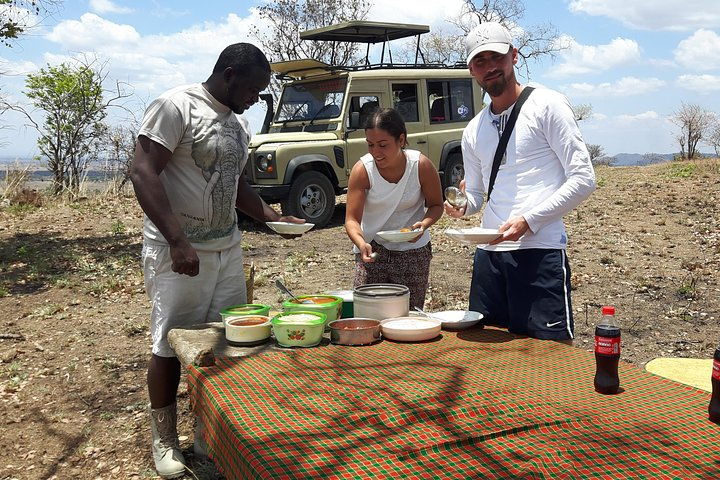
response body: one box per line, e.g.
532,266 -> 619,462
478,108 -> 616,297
130,135 -> 200,277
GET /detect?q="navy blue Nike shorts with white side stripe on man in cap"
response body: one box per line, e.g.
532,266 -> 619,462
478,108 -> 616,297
469,248 -> 575,340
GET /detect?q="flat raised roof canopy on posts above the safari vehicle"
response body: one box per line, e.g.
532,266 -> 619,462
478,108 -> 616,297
300,20 -> 430,65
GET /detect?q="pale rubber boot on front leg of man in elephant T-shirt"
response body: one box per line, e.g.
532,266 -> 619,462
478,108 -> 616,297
149,403 -> 185,478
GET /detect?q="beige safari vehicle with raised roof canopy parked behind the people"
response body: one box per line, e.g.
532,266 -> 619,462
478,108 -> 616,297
245,21 -> 482,226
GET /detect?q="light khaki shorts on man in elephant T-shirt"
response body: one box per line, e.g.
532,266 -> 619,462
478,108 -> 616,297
142,243 -> 247,357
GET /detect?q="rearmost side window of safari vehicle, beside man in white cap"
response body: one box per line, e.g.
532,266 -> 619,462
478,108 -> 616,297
427,79 -> 475,123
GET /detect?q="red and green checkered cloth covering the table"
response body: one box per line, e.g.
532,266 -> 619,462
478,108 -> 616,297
188,328 -> 720,480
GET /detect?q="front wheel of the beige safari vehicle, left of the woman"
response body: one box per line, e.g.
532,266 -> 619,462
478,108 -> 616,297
280,171 -> 335,227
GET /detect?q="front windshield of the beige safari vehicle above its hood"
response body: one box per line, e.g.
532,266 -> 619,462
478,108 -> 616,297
275,78 -> 347,122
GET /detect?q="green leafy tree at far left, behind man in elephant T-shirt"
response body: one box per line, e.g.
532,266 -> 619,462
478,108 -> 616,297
2,59 -> 128,194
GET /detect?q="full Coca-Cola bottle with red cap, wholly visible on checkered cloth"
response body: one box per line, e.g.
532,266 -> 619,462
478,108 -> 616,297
595,306 -> 620,395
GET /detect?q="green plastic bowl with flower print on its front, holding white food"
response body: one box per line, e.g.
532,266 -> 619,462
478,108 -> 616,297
270,310 -> 327,347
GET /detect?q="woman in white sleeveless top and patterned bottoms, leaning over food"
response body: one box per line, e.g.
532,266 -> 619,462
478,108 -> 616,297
345,108 -> 443,308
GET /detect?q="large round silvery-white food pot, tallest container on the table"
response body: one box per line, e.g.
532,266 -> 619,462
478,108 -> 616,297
353,283 -> 410,320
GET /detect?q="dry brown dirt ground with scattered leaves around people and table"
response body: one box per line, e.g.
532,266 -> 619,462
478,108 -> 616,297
0,161 -> 720,480
